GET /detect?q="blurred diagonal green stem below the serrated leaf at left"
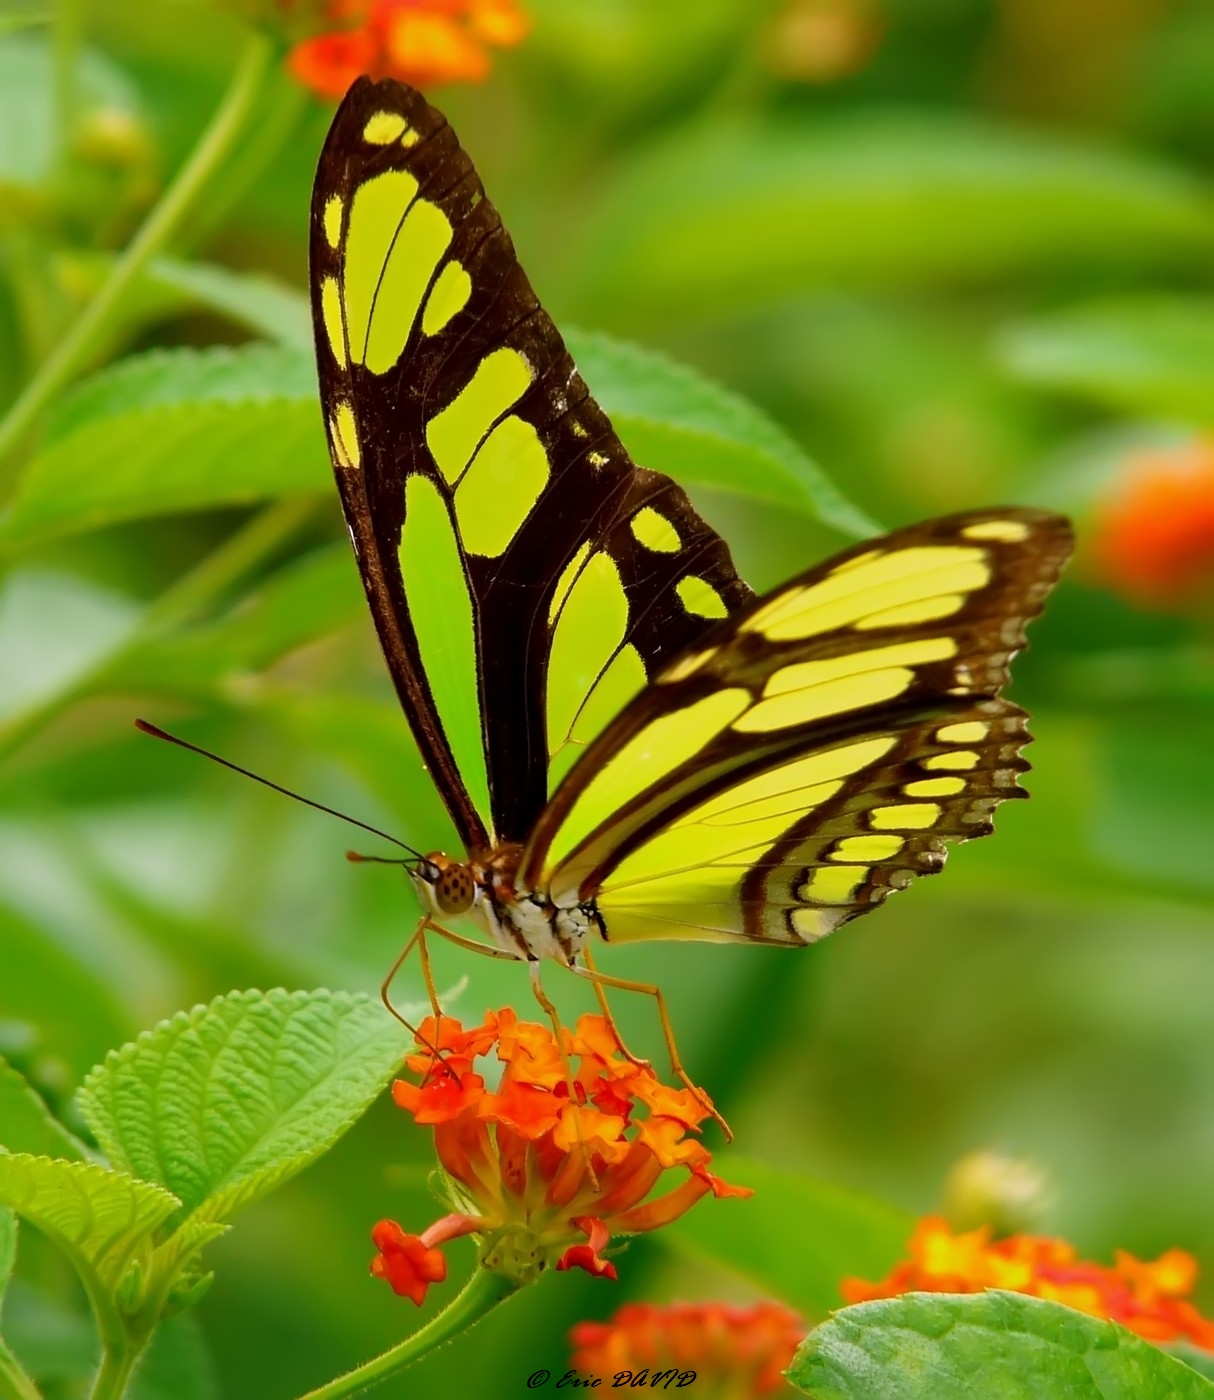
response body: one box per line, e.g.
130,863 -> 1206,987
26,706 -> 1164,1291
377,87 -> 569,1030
0,496 -> 316,759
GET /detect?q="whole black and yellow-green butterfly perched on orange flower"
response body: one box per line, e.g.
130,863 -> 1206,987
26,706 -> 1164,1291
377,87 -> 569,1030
311,78 -> 1071,1072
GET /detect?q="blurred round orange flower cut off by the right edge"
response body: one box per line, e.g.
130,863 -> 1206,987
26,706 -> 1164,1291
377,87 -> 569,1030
1089,438 -> 1214,608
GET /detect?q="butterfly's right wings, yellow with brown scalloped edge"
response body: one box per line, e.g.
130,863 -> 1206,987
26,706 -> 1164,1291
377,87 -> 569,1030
521,510 -> 1071,942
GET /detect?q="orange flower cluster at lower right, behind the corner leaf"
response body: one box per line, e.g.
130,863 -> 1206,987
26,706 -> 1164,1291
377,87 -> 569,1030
840,1215 -> 1214,1351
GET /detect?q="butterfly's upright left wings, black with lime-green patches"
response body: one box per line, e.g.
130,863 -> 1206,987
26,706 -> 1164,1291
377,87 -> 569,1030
311,80 -> 752,850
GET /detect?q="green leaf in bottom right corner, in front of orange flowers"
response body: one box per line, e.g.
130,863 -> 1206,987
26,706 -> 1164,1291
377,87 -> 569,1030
787,1291 -> 1214,1400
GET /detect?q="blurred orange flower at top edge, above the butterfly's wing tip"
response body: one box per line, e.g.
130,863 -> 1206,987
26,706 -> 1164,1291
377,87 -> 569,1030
288,0 -> 531,98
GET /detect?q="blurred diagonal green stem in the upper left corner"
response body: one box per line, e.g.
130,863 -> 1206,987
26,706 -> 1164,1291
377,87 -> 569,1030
0,32 -> 276,481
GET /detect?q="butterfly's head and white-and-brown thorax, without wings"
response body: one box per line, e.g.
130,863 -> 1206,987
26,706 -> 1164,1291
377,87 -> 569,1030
416,844 -> 602,963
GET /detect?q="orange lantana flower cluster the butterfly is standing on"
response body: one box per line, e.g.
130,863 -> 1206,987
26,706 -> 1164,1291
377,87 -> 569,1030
371,1008 -> 751,1303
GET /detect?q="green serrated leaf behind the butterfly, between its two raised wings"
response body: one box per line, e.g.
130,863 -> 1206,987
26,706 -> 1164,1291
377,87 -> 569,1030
566,330 -> 881,539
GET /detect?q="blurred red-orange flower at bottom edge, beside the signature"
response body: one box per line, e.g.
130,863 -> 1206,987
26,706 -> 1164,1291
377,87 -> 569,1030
568,1302 -> 807,1400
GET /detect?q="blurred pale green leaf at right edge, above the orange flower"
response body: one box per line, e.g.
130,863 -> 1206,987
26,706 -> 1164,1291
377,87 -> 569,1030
998,297 -> 1214,424
